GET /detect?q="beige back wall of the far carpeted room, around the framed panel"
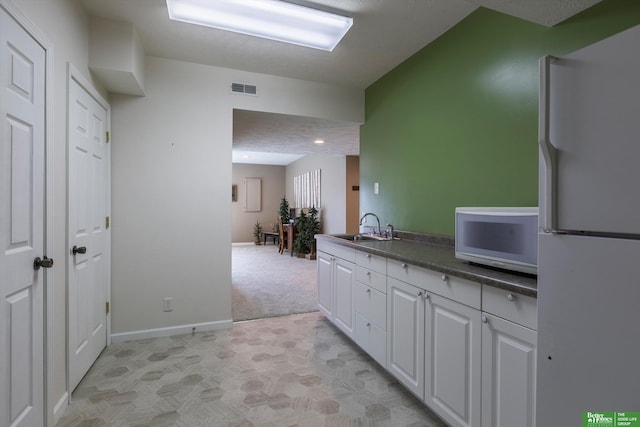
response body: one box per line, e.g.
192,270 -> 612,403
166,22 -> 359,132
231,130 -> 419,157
231,163 -> 286,243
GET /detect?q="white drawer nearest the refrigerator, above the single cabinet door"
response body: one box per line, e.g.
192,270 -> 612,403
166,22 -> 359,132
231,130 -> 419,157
482,285 -> 538,330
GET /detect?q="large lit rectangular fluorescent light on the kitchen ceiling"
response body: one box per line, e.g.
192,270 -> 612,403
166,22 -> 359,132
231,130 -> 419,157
167,0 -> 353,51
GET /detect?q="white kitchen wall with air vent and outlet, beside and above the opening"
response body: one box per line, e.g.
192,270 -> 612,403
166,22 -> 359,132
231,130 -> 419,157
111,57 -> 364,334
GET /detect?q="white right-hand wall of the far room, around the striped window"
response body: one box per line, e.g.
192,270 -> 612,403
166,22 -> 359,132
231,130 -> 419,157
287,154 -> 347,234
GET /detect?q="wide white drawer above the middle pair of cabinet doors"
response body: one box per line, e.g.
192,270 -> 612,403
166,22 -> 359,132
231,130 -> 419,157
387,260 -> 482,309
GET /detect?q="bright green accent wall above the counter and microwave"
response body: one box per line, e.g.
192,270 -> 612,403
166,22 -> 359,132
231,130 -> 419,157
360,0 -> 640,236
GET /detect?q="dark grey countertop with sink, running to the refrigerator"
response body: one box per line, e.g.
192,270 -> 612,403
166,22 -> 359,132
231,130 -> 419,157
316,232 -> 538,298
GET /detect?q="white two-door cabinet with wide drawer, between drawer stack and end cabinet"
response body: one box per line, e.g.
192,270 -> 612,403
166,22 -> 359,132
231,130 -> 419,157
387,260 -> 482,427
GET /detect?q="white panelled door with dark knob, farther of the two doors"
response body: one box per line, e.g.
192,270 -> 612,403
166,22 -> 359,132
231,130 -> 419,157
68,75 -> 110,390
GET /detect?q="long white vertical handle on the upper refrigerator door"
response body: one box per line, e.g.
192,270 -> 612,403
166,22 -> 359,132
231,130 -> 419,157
538,55 -> 557,233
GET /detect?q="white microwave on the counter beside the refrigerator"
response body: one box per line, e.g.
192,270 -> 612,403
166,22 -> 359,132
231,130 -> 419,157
456,207 -> 538,274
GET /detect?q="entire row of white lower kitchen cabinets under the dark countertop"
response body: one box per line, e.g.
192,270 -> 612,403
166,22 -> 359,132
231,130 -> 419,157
317,241 -> 537,427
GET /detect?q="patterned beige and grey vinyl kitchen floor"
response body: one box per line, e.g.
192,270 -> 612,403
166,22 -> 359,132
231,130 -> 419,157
56,312 -> 445,427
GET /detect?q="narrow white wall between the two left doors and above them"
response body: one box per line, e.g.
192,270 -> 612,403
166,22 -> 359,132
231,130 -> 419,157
13,0 -> 105,418
